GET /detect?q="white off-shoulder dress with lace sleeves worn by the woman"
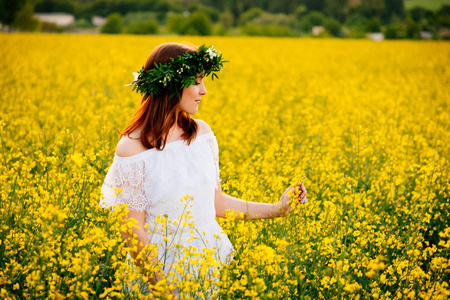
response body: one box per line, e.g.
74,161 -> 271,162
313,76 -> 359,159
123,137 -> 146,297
100,132 -> 234,290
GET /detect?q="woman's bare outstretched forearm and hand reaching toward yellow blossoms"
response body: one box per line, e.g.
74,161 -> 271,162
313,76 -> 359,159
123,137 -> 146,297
214,184 -> 307,220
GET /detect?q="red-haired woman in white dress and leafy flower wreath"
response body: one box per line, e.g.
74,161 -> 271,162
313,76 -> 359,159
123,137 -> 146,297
102,43 -> 307,296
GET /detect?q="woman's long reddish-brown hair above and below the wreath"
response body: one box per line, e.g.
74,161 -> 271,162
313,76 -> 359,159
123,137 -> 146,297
119,43 -> 198,150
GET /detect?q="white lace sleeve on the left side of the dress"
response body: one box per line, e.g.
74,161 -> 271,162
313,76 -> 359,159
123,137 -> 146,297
100,157 -> 148,211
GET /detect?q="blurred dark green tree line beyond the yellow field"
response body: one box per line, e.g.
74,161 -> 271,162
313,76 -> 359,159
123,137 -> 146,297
0,0 -> 450,38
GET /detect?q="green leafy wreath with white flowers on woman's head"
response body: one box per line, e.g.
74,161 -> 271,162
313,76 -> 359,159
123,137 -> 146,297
126,45 -> 226,98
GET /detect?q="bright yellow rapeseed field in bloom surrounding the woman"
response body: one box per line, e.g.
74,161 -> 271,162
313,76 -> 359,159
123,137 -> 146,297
0,34 -> 450,299
